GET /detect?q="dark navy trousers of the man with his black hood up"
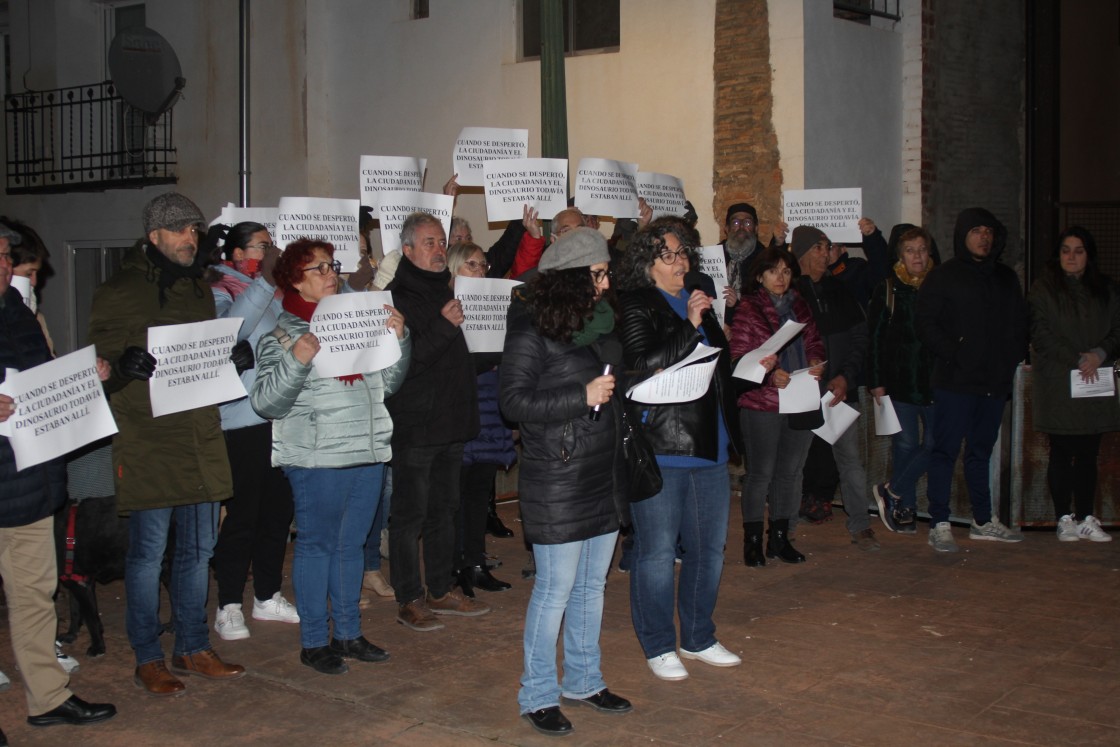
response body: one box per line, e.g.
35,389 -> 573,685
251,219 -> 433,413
928,389 -> 1006,524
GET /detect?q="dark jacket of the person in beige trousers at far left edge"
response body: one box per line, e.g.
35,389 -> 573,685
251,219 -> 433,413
0,286 -> 66,527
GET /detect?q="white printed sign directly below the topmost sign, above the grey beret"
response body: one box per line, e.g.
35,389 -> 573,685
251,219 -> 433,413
483,158 -> 568,222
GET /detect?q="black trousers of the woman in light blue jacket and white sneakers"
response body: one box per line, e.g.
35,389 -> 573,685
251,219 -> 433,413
213,423 -> 293,606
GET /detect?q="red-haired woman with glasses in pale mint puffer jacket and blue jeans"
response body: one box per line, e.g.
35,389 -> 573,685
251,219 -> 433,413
250,239 -> 411,674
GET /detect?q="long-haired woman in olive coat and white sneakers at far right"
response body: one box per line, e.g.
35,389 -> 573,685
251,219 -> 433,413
1028,226 -> 1120,542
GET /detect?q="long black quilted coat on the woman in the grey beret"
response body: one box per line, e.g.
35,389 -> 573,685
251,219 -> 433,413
500,300 -> 625,544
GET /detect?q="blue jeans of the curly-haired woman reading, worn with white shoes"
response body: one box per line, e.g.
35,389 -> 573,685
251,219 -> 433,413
631,464 -> 731,659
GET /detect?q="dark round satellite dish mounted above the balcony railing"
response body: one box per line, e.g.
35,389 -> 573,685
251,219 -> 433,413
109,26 -> 187,124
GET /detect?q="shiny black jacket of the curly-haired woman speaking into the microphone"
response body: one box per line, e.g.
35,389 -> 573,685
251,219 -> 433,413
619,288 -> 743,461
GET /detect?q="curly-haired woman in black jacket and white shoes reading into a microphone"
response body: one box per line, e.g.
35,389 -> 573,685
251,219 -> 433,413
617,220 -> 741,680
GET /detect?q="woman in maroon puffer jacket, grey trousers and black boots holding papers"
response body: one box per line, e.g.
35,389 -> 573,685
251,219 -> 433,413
731,246 -> 824,568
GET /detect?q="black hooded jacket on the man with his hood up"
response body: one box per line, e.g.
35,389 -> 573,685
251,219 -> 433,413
917,207 -> 1027,398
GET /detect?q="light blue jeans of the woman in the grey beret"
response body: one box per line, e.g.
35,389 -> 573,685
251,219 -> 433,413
517,532 -> 618,713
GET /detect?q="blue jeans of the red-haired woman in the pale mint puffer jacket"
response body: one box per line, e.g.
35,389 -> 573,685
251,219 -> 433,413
284,464 -> 384,648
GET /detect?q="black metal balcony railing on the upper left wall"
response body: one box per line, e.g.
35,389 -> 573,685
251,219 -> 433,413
4,81 -> 178,195
